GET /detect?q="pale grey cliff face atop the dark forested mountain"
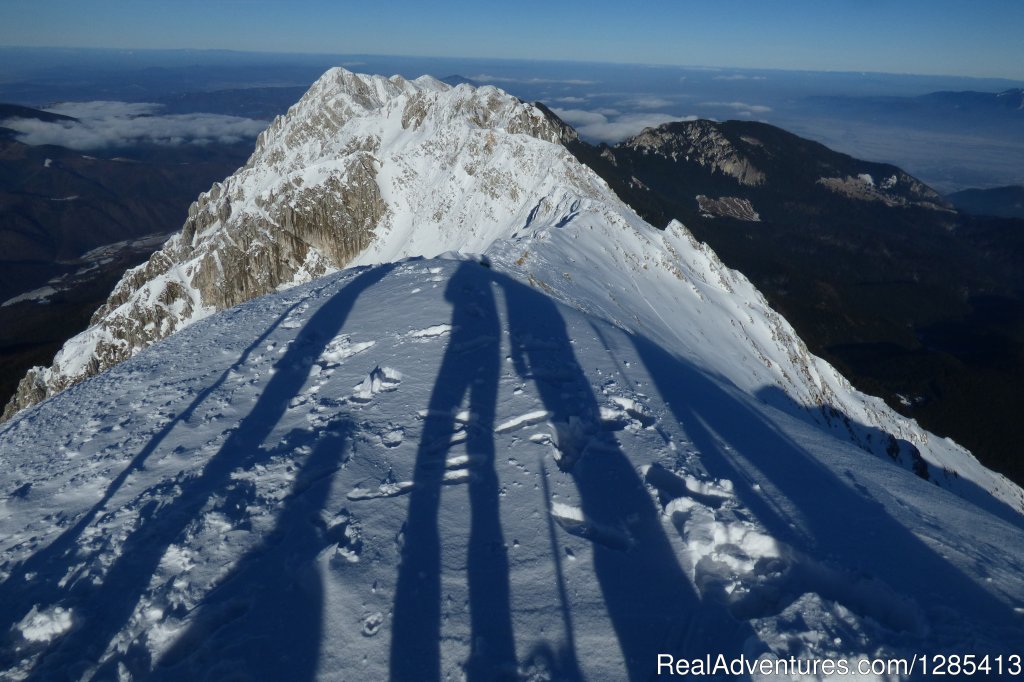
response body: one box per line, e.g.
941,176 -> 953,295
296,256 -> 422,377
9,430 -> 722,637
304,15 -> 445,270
622,121 -> 765,186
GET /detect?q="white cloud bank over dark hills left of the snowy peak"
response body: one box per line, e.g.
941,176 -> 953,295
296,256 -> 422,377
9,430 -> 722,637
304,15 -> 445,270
0,101 -> 267,151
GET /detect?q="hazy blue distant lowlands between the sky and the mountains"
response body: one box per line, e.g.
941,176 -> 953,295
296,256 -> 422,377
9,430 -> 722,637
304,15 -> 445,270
0,47 -> 1024,191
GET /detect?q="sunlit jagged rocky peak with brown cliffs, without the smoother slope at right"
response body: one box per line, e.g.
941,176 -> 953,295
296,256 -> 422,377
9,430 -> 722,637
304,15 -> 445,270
3,69 -> 594,419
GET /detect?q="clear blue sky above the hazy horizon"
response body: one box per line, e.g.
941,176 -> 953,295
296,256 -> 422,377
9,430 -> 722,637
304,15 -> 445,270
0,0 -> 1024,80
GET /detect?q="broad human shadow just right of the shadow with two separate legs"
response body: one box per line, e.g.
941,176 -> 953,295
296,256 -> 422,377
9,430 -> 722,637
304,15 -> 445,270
495,273 -> 753,680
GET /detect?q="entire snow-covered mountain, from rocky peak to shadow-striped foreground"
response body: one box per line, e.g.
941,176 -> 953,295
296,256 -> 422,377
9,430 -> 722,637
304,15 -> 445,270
6,70 -> 1024,680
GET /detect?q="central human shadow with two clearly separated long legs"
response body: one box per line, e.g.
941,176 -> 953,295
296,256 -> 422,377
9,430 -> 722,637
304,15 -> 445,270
390,261 -> 516,682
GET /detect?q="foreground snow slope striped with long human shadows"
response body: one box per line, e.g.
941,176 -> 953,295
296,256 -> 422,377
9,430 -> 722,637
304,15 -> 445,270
0,256 -> 1024,680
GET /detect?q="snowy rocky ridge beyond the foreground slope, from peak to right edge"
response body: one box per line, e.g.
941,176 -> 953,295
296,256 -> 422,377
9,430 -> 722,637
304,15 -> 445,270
8,69 -> 1024,516
